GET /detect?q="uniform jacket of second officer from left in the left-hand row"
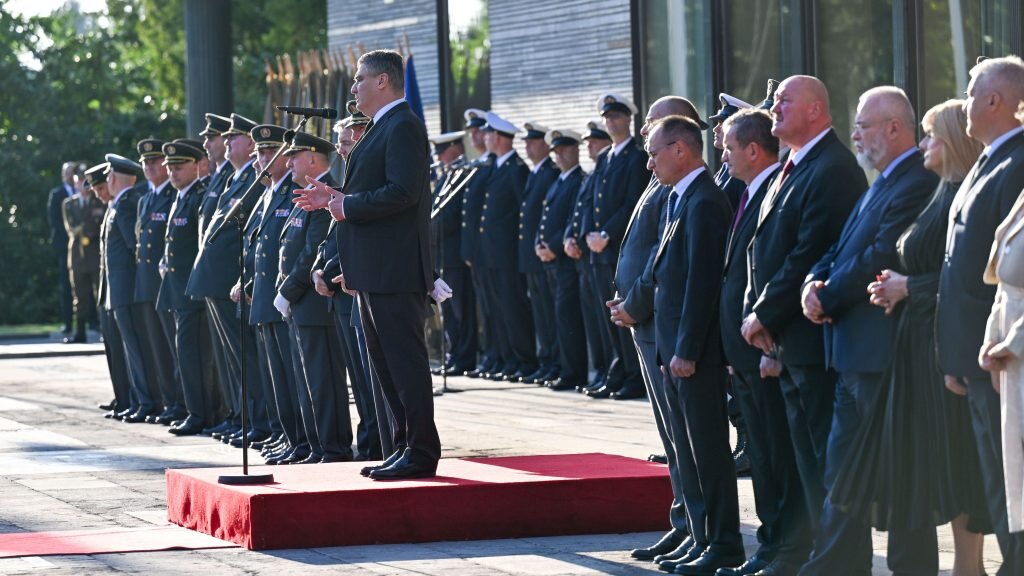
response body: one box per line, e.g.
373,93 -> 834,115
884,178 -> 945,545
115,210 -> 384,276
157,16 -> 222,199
100,184 -> 145,310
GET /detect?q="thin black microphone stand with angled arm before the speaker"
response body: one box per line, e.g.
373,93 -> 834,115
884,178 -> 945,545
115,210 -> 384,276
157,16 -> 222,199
218,116 -> 309,486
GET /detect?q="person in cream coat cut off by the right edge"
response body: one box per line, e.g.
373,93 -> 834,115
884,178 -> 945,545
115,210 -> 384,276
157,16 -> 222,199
978,104 -> 1024,532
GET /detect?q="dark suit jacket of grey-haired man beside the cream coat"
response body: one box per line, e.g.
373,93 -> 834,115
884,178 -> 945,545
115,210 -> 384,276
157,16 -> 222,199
936,134 -> 1024,379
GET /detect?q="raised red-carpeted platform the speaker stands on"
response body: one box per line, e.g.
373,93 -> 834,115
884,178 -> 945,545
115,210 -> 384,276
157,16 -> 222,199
167,454 -> 672,550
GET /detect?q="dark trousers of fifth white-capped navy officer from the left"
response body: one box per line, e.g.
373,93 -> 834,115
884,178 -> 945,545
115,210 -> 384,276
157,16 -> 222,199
544,256 -> 587,386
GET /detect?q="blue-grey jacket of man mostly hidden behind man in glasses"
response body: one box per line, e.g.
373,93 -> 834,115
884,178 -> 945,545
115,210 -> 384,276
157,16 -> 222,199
615,177 -> 670,342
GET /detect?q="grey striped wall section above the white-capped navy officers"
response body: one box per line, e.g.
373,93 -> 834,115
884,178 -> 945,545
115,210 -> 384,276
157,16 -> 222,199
488,0 -> 630,168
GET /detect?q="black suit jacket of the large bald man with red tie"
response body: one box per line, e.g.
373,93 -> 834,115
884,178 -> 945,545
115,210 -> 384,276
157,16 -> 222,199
744,130 -> 867,365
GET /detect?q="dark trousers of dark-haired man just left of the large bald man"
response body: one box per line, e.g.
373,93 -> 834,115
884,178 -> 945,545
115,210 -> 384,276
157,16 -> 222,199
732,370 -> 812,564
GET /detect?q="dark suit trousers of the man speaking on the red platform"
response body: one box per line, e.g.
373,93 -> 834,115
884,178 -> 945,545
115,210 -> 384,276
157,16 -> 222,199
358,292 -> 441,465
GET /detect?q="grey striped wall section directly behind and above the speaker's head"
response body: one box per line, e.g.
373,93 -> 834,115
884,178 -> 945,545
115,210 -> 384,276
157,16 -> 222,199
327,0 -> 440,134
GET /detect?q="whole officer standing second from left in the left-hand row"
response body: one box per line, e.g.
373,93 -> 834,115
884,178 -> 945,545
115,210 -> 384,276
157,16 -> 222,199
100,154 -> 160,423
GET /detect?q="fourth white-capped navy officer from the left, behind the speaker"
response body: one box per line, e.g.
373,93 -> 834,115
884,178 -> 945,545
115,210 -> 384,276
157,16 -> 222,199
516,122 -> 559,384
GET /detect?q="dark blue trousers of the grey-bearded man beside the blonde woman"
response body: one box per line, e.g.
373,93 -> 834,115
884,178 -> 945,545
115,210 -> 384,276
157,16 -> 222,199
800,372 -> 939,576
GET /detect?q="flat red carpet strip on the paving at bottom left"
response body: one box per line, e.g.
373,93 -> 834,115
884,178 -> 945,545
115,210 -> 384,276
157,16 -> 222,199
0,526 -> 236,558
